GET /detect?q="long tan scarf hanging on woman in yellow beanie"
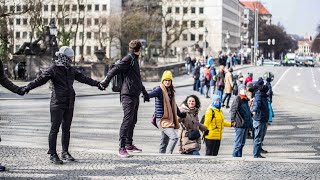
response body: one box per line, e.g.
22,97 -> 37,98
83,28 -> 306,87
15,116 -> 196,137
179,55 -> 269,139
160,84 -> 180,129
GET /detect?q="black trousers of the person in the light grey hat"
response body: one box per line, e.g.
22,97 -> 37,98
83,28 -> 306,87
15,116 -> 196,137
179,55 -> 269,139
48,107 -> 74,154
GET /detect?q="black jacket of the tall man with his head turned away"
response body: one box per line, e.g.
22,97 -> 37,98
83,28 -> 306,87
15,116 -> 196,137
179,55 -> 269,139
106,53 -> 147,96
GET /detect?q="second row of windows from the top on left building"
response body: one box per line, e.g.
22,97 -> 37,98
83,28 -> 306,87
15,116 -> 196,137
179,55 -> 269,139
9,18 -> 107,26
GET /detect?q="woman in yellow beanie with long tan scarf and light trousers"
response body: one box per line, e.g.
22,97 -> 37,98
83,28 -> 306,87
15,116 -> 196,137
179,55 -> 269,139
148,70 -> 186,154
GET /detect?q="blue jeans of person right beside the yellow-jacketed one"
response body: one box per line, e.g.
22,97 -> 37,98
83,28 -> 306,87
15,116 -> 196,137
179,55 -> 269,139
232,128 -> 248,157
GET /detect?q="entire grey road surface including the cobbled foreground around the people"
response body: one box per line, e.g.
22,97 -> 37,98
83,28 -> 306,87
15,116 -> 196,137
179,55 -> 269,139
0,67 -> 320,179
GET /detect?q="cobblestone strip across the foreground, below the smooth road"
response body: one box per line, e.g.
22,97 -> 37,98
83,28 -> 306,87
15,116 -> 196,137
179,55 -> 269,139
0,146 -> 320,180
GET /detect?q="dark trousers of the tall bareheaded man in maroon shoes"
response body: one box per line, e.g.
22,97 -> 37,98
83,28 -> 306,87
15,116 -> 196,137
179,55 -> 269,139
119,95 -> 139,148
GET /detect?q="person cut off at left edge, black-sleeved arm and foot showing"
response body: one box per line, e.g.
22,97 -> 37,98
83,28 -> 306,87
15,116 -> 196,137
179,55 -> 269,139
0,60 -> 25,171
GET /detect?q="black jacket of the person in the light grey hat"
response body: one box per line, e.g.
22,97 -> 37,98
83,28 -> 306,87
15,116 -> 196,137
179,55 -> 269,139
27,65 -> 99,108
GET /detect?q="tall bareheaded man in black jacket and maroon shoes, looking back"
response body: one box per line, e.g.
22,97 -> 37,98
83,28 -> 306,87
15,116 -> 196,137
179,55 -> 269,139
101,40 -> 149,158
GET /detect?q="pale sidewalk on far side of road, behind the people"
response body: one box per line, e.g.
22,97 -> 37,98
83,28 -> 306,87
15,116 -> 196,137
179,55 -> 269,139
0,65 -> 252,100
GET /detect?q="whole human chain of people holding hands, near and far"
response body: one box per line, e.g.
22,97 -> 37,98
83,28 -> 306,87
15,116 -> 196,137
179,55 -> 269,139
0,40 -> 272,170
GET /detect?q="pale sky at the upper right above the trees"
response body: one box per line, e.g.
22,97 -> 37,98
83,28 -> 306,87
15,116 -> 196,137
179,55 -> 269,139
261,0 -> 320,36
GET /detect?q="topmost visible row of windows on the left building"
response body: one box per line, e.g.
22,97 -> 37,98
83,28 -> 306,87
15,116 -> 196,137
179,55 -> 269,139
0,4 -> 107,13
